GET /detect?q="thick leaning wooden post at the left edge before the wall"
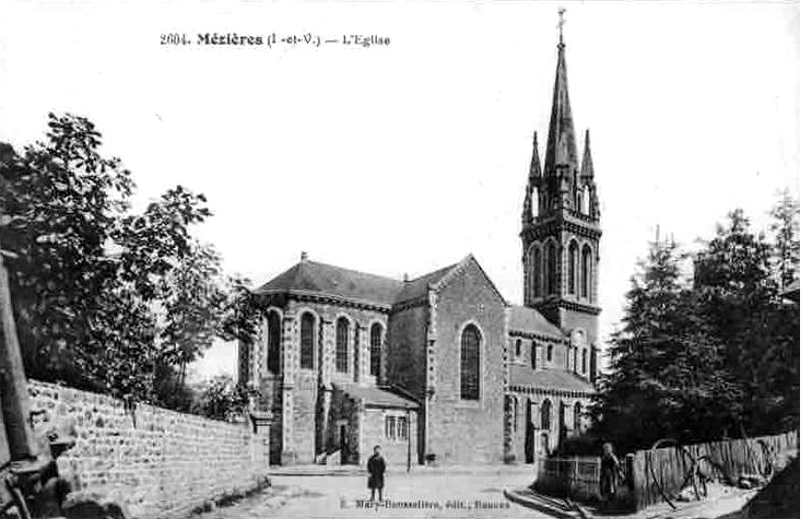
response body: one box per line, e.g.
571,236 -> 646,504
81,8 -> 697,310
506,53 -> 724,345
0,226 -> 37,461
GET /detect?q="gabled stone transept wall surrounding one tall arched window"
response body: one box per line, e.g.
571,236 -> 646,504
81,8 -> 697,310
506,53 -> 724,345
426,262 -> 506,464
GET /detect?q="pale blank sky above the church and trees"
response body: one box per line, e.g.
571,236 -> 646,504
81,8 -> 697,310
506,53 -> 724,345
0,0 -> 801,382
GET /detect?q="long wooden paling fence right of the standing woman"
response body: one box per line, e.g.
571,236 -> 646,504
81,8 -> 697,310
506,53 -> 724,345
627,431 -> 798,510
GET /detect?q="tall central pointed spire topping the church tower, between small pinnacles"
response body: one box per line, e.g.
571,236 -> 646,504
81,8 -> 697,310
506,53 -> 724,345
545,9 -> 578,176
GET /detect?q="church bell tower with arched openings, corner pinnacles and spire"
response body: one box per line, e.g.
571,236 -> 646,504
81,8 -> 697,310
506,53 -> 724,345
520,15 -> 601,378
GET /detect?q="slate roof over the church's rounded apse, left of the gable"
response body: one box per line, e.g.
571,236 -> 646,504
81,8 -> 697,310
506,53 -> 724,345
256,260 -> 403,305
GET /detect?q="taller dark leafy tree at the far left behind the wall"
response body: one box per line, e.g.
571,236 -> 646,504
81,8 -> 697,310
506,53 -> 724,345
0,114 -> 134,388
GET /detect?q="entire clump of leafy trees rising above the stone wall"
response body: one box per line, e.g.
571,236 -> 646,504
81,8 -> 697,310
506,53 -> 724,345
0,114 -> 228,406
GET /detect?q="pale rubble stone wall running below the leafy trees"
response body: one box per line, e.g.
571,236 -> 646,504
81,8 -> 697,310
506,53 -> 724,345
28,380 -> 269,519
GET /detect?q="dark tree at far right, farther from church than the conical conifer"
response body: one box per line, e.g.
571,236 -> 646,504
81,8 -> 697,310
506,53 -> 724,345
694,210 -> 798,434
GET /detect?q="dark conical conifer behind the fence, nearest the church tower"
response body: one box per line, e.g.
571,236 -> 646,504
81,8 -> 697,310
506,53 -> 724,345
590,238 -> 737,450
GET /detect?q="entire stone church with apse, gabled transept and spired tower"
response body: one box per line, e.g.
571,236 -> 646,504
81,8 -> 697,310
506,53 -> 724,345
239,27 -> 601,466
